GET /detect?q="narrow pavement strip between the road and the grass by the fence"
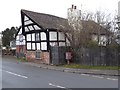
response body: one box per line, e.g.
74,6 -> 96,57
24,62 -> 119,76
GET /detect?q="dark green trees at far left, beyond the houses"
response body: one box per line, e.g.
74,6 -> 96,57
2,27 -> 17,46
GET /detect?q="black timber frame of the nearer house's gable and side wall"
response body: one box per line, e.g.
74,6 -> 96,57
21,10 -> 67,51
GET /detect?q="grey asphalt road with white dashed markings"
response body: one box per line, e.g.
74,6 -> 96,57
1,57 -> 118,89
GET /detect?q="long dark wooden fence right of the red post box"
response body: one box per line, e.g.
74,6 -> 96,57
73,47 -> 120,66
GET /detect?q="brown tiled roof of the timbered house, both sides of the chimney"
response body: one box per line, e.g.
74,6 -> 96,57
21,9 -> 110,34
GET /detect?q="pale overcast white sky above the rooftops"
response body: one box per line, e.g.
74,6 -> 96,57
0,0 -> 119,32
